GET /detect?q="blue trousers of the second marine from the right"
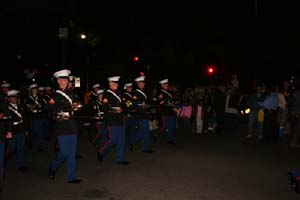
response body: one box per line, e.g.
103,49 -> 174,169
137,119 -> 150,151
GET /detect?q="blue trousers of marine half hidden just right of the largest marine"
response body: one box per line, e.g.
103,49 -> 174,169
91,123 -> 107,148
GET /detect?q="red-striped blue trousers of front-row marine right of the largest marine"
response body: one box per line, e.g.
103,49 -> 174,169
98,125 -> 125,162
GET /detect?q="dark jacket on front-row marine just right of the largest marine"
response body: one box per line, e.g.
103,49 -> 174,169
102,89 -> 124,126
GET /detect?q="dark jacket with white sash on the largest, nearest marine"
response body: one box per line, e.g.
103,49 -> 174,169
48,90 -> 78,136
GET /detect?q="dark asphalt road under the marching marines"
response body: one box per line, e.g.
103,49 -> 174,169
1,125 -> 300,200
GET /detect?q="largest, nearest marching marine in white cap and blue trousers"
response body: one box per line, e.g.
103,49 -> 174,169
48,69 -> 82,183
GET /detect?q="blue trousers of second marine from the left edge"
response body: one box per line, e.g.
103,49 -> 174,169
8,132 -> 26,168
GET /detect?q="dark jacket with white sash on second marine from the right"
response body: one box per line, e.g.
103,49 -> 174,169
132,89 -> 150,119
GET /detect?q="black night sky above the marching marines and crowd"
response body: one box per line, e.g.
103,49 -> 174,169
0,0 -> 300,88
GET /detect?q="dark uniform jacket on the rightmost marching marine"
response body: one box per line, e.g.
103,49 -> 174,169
158,89 -> 176,116
